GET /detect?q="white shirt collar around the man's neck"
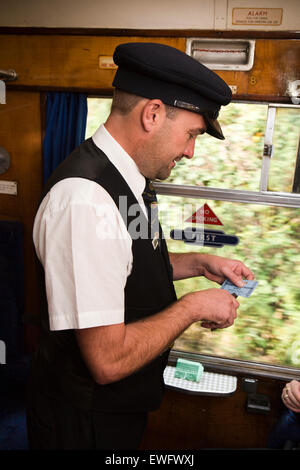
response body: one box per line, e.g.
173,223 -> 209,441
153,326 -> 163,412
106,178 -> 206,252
92,124 -> 146,200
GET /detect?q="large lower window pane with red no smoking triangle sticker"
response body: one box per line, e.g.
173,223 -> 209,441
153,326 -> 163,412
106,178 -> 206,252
159,195 -> 300,366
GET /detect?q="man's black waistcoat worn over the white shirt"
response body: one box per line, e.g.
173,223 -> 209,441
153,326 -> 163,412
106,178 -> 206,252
33,139 -> 176,411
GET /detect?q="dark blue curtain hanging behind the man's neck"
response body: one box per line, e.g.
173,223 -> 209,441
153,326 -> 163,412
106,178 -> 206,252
43,92 -> 87,183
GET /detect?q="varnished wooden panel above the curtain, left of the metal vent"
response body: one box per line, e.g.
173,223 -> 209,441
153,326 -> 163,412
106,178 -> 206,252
0,35 -> 185,90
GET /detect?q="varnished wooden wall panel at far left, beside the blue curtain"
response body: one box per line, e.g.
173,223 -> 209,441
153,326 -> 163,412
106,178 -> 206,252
0,91 -> 42,349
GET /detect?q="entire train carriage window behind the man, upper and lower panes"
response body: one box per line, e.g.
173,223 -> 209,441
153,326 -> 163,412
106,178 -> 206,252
87,98 -> 300,367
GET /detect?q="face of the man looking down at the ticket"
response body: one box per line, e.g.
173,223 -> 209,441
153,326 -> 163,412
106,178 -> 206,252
138,110 -> 206,180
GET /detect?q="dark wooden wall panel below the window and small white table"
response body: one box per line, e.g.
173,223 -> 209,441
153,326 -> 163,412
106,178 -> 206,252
142,377 -> 284,450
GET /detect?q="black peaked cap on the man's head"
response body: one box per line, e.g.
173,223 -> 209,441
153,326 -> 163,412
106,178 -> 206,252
113,42 -> 232,139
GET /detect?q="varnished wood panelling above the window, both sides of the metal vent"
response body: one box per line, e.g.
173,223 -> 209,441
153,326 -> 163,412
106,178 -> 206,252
0,34 -> 300,99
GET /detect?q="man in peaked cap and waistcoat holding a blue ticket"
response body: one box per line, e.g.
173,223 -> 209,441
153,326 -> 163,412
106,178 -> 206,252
28,43 -> 253,449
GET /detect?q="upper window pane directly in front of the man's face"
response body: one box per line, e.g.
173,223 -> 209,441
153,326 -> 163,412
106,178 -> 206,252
168,103 -> 267,191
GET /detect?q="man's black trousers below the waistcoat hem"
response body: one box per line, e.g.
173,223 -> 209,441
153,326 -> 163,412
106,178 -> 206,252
27,393 -> 147,450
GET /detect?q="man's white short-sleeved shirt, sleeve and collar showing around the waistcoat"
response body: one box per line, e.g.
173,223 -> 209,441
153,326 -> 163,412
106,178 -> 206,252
33,125 -> 145,330
